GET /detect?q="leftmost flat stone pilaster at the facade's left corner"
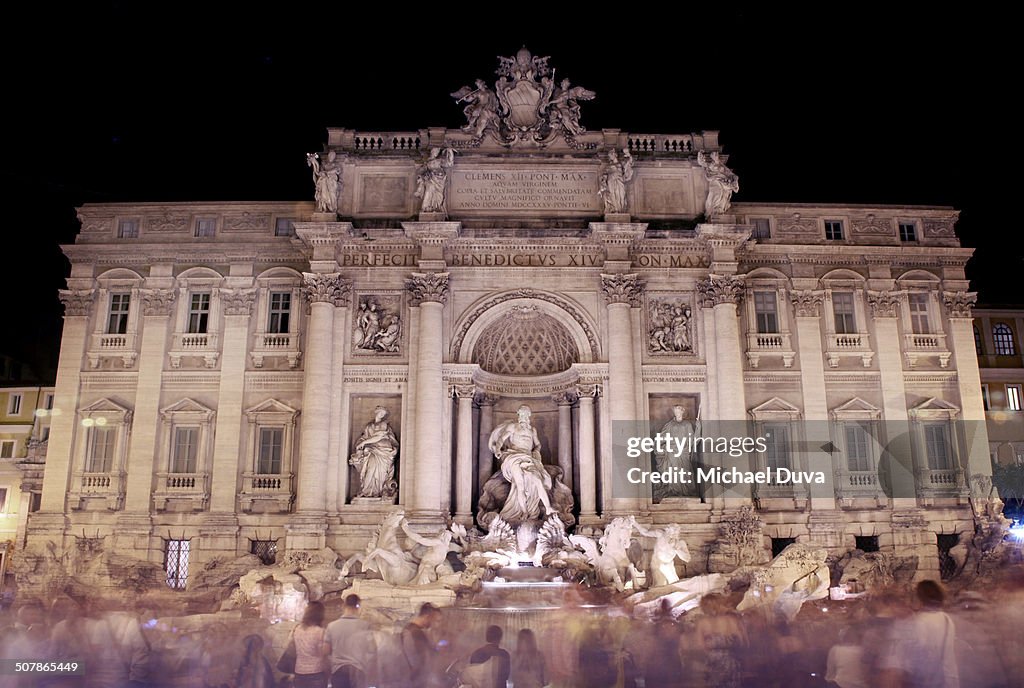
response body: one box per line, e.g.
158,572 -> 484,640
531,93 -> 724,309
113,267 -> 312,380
37,289 -> 96,524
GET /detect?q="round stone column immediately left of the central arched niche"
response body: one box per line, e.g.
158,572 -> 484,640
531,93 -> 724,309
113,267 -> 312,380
406,272 -> 449,520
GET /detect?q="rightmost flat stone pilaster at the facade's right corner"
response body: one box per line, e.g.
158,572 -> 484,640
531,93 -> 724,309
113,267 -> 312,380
942,292 -> 992,484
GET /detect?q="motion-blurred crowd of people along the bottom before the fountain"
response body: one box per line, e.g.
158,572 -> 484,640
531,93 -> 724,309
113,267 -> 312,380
0,581 -> 1024,688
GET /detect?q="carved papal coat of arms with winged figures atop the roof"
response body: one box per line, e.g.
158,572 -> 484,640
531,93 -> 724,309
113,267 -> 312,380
452,47 -> 596,145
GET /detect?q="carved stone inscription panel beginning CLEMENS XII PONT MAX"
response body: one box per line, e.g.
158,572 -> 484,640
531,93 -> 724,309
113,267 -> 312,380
450,168 -> 601,214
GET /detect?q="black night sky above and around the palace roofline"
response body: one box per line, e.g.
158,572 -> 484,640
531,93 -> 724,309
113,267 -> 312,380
0,3 -> 1011,378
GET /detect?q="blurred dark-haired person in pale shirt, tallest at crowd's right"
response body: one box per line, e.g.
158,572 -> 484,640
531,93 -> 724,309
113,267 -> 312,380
879,581 -> 959,688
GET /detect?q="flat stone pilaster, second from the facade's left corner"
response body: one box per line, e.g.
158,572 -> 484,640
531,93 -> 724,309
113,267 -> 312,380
125,289 -> 175,519
